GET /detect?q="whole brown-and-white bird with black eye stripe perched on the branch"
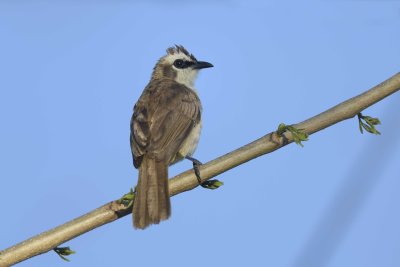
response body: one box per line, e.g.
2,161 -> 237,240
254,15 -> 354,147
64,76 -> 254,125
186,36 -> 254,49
130,45 -> 213,229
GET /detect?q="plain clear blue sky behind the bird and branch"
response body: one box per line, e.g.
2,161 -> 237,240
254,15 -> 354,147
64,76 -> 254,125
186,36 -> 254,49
0,0 -> 400,267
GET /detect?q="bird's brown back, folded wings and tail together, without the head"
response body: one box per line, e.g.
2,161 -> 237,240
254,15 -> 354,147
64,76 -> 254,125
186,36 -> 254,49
131,78 -> 201,229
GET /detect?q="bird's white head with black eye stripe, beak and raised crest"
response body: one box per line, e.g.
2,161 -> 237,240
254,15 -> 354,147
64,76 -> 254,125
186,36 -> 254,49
152,45 -> 213,87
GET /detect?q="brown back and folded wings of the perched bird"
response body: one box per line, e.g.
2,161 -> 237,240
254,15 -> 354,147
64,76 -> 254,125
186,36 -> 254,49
131,79 -> 201,168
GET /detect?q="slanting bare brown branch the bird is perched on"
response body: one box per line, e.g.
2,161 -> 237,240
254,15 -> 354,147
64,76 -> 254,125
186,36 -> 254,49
0,73 -> 400,267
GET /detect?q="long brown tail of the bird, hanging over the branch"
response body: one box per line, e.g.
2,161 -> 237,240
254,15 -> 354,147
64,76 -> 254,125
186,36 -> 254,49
133,156 -> 171,229
